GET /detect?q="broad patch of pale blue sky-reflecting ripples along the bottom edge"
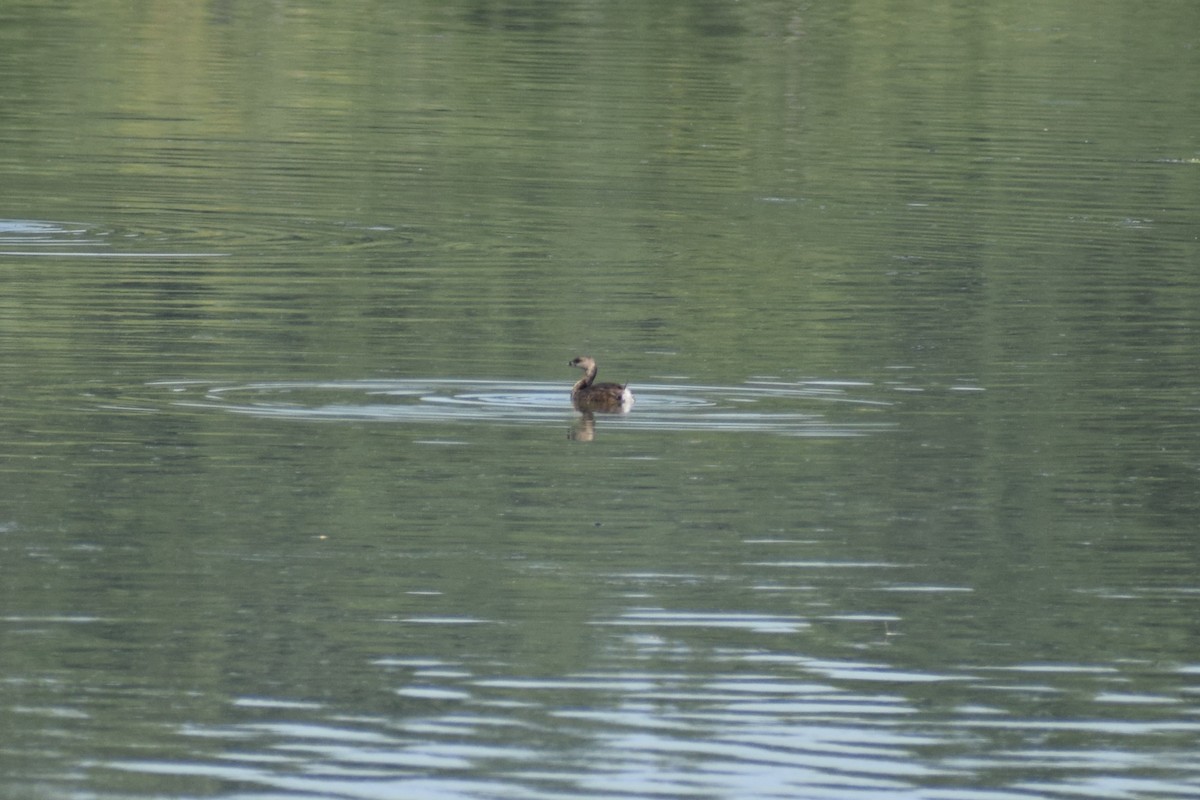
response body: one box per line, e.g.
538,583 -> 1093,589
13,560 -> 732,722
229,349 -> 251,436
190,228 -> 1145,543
97,642 -> 1198,800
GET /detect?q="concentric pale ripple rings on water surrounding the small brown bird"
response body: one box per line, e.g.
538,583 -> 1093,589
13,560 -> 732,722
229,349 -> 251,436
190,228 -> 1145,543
151,379 -> 892,437
